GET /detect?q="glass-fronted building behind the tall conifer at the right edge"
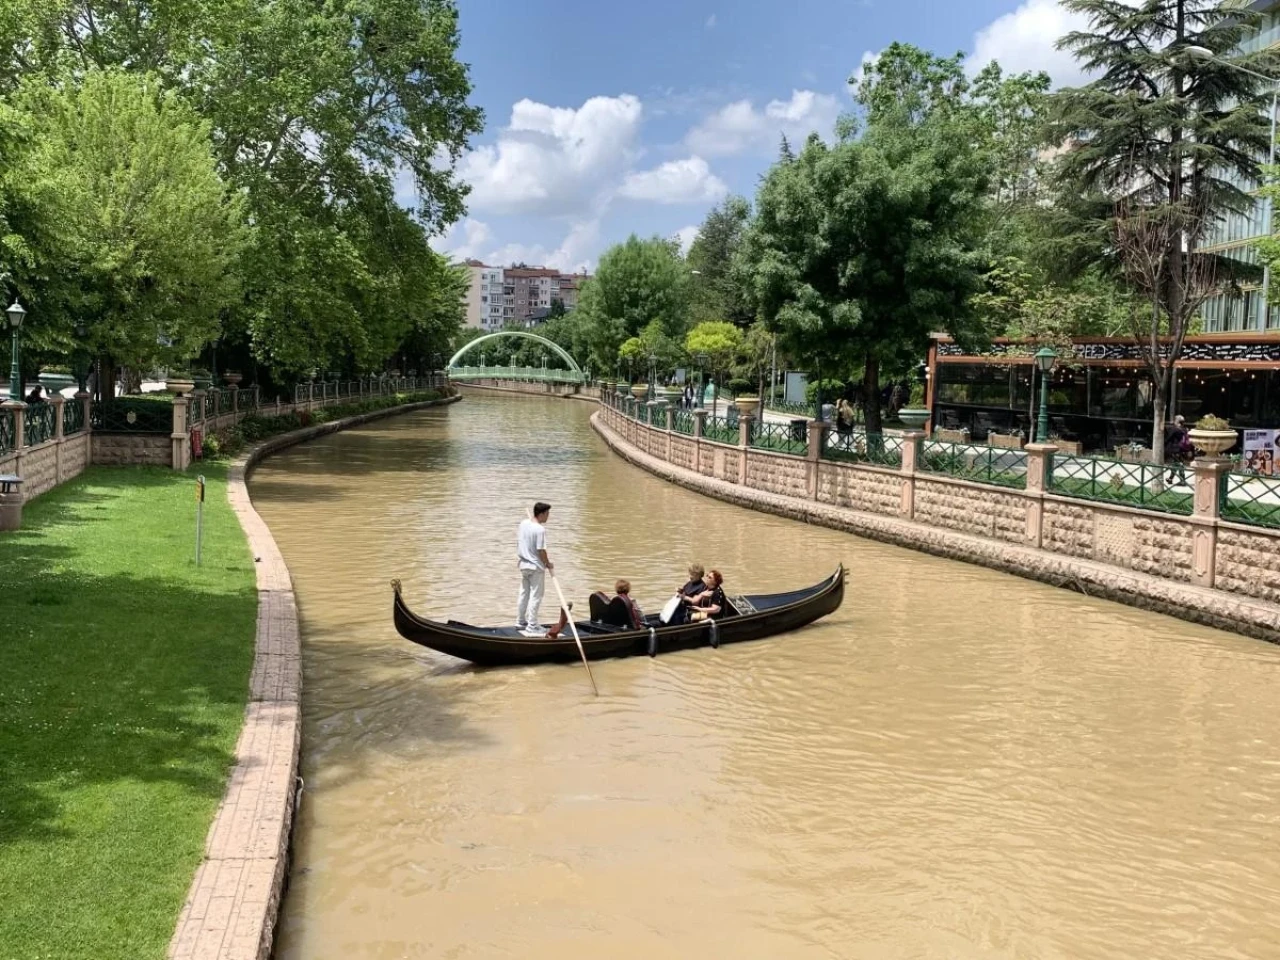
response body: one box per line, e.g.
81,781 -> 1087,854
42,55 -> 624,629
1201,0 -> 1280,333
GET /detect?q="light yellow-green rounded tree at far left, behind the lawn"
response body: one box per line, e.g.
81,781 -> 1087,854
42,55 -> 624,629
10,70 -> 247,371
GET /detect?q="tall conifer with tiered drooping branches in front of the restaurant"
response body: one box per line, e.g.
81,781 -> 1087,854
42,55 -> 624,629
1055,0 -> 1277,461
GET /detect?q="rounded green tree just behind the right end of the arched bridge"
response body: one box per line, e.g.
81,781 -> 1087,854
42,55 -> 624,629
573,234 -> 689,370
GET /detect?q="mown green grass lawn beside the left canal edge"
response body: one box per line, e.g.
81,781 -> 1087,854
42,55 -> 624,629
0,463 -> 257,960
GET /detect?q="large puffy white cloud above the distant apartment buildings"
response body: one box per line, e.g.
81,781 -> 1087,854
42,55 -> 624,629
458,93 -> 641,215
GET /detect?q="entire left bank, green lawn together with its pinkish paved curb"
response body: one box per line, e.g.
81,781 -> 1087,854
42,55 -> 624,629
0,394 -> 457,960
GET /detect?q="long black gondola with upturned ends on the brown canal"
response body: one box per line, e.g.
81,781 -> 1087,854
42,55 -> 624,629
392,566 -> 846,667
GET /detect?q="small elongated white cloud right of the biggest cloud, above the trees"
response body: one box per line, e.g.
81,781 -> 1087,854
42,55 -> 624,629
685,90 -> 840,156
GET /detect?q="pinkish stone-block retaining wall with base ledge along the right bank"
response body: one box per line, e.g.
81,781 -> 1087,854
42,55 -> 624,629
591,406 -> 1280,643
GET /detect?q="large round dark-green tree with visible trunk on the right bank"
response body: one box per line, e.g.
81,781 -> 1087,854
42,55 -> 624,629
742,104 -> 987,433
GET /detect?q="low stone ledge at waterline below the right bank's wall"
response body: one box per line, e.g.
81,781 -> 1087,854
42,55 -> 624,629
591,412 -> 1280,643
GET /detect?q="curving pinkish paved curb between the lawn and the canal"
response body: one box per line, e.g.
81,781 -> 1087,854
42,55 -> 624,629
168,396 -> 462,960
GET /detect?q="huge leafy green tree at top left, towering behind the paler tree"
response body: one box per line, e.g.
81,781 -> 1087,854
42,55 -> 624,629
0,0 -> 481,370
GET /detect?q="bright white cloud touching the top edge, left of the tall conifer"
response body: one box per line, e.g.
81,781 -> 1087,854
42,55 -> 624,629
969,0 -> 1088,87
